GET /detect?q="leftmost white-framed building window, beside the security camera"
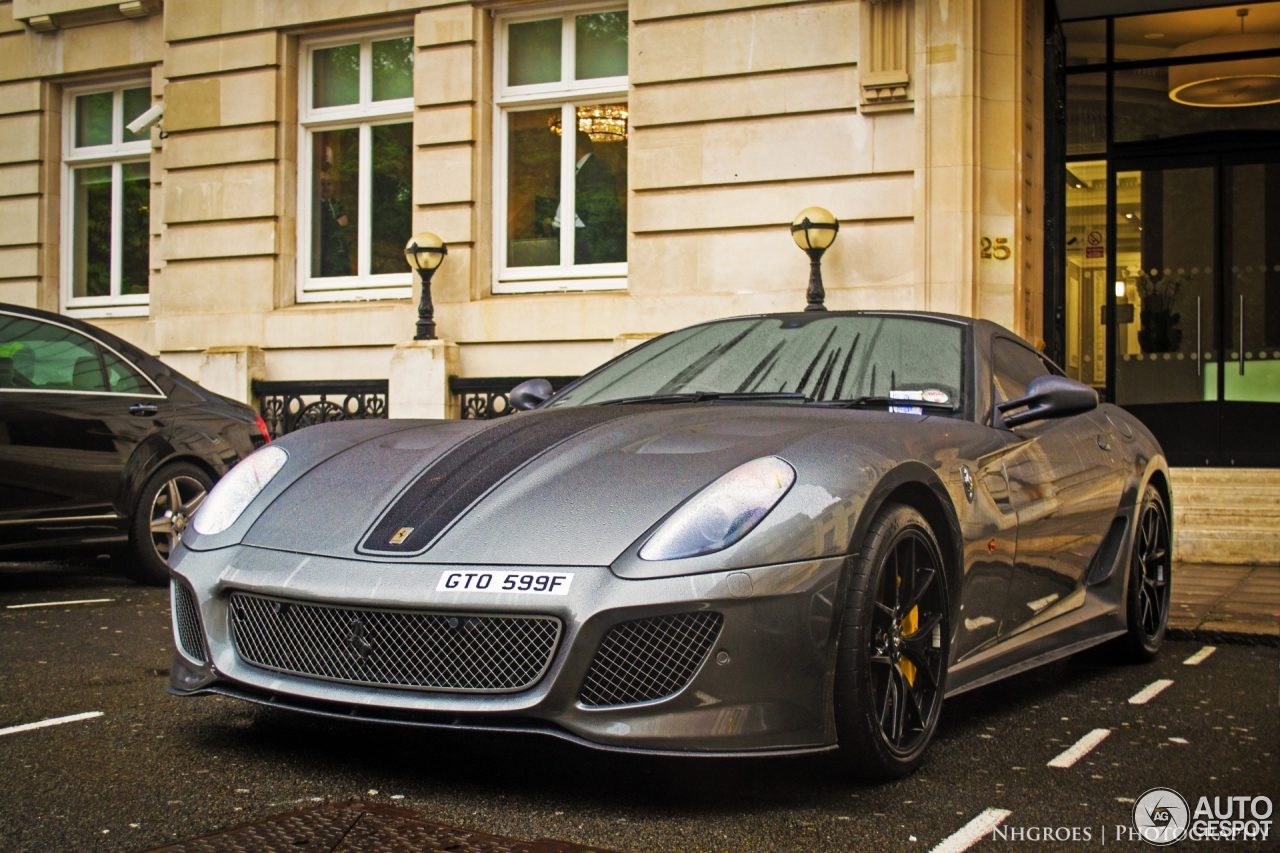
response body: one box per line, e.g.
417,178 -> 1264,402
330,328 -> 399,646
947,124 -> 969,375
61,81 -> 151,316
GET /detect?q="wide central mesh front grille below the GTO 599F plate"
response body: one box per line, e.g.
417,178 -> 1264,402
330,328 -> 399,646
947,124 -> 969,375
230,593 -> 561,693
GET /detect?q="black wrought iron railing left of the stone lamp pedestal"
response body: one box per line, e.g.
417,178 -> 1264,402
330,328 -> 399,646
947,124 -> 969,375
253,379 -> 387,438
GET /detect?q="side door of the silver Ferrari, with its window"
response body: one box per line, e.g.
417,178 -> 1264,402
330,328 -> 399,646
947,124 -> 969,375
992,338 -> 1120,635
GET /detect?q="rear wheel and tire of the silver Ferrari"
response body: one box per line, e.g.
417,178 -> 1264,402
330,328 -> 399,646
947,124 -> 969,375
1116,485 -> 1172,663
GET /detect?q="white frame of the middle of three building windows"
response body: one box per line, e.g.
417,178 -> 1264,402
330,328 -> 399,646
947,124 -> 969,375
296,27 -> 417,302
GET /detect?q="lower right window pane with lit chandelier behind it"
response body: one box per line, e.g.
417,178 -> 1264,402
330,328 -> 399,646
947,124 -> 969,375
573,104 -> 627,264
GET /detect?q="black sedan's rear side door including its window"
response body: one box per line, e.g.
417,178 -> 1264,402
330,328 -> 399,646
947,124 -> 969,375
0,313 -> 169,546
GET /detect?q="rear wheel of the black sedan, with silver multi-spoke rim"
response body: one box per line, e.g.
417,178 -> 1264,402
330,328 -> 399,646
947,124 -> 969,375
125,462 -> 214,585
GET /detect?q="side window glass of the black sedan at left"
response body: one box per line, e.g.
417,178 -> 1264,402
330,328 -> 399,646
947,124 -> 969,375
0,314 -> 157,396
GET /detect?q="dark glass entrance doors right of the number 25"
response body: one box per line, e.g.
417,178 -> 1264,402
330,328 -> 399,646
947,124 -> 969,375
1108,154 -> 1280,466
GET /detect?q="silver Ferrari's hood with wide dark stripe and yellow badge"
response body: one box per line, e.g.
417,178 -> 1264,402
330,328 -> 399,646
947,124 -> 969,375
243,406 -> 847,566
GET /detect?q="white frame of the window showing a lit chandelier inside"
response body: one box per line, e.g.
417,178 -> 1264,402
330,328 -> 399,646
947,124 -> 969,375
493,3 -> 630,293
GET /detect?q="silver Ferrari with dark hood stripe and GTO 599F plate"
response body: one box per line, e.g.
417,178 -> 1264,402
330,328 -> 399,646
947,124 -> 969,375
170,311 -> 1170,777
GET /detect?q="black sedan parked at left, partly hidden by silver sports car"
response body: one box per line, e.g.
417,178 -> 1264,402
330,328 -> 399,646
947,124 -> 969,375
0,304 -> 268,584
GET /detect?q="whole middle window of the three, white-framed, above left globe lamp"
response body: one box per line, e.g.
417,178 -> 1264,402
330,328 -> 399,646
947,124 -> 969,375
298,32 -> 413,302
